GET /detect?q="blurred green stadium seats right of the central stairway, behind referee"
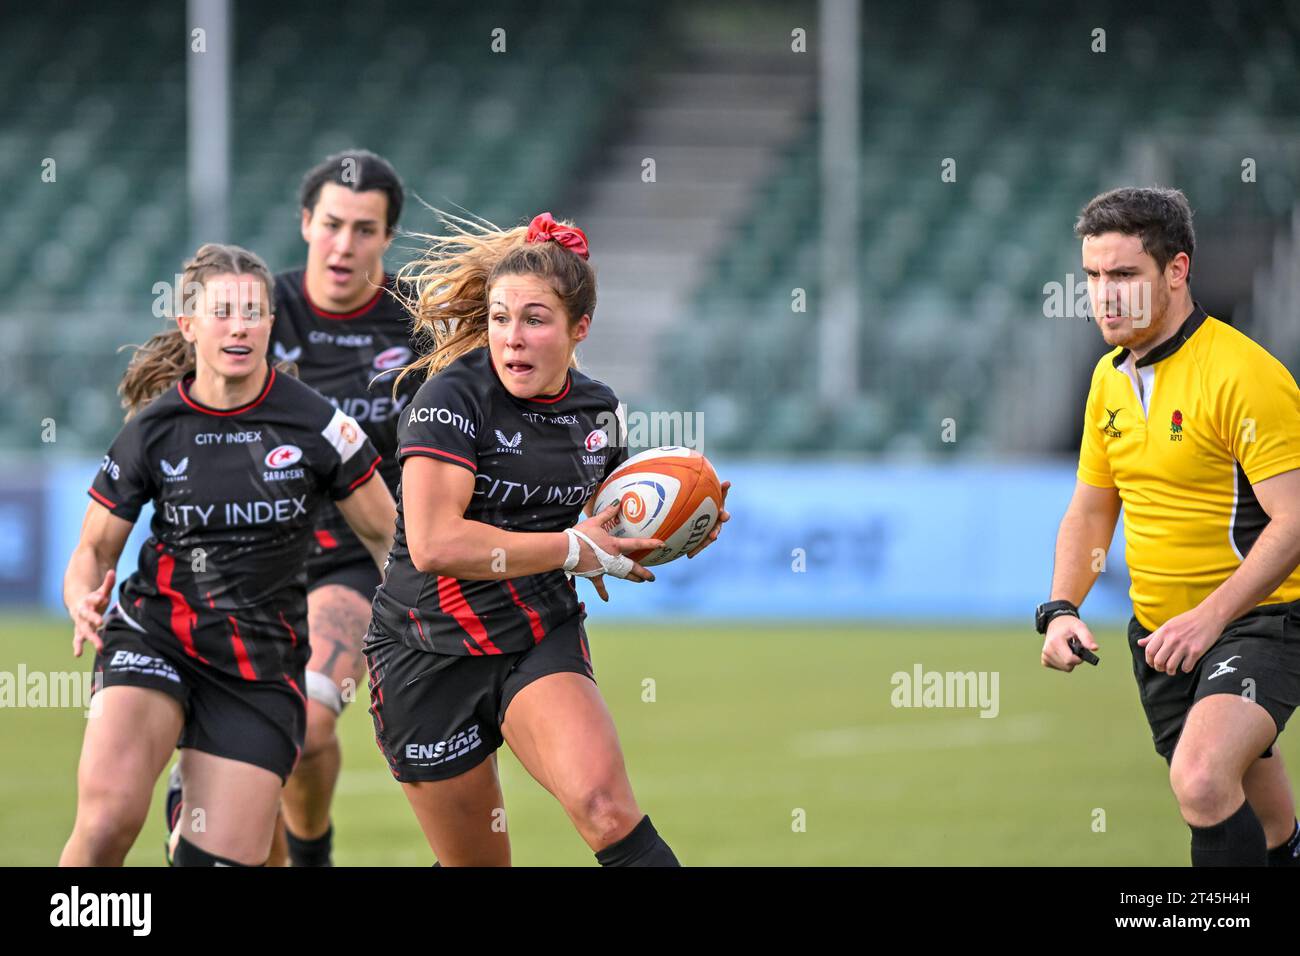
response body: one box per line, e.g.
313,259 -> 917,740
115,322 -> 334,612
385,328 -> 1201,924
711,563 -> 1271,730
660,0 -> 1300,454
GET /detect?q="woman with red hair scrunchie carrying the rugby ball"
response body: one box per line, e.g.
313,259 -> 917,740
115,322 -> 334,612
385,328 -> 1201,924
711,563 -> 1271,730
364,213 -> 728,866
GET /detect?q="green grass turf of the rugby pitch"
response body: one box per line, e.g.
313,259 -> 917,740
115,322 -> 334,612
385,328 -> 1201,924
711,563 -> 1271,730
0,615 -> 1300,866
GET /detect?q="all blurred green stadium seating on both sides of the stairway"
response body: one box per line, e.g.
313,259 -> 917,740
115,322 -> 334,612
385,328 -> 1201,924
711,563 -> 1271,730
0,0 -> 1300,454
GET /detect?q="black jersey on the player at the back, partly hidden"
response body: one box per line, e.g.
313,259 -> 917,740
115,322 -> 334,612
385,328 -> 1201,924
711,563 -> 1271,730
270,269 -> 420,566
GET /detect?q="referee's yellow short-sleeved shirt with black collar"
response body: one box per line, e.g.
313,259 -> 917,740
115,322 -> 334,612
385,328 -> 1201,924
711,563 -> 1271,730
1079,306 -> 1300,631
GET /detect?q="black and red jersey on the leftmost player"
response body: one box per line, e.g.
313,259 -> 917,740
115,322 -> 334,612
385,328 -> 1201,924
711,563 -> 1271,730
90,367 -> 380,680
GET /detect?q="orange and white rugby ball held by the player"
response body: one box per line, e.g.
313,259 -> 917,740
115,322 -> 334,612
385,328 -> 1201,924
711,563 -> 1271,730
593,446 -> 723,567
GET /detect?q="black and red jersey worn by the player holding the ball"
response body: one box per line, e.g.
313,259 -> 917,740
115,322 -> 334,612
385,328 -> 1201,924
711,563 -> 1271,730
373,349 -> 627,654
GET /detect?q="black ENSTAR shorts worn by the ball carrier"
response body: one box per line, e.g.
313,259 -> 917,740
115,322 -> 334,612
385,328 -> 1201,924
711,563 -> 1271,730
363,611 -> 595,783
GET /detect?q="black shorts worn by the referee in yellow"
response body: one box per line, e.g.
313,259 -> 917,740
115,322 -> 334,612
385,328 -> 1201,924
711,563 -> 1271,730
1128,602 -> 1300,761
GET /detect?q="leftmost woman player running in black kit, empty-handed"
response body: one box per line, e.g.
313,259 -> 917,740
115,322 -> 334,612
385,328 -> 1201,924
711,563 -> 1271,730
60,245 -> 394,866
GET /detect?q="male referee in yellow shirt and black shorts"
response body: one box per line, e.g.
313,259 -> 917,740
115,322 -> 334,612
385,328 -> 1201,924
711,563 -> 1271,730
1036,189 -> 1300,866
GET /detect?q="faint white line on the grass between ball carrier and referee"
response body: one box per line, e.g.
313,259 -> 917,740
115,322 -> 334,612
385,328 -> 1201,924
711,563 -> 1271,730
790,710 -> 1054,757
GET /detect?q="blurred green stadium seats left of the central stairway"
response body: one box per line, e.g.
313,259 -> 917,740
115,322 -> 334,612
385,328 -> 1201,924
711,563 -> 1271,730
0,0 -> 659,454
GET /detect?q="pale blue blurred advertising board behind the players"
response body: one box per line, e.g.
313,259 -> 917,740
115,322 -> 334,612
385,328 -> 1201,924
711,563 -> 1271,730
27,462 -> 1130,622
